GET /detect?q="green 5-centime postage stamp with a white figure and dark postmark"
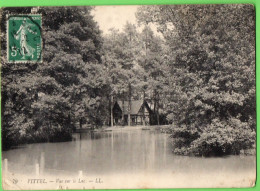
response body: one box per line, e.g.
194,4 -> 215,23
7,14 -> 42,63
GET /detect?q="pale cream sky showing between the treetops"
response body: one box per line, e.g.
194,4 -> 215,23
92,5 -> 160,35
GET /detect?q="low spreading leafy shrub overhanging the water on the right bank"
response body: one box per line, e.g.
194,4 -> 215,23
171,118 -> 256,156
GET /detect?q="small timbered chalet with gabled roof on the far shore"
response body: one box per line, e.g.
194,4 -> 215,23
113,100 -> 152,125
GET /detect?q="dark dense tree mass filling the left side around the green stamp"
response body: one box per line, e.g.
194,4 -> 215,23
1,7 -> 109,147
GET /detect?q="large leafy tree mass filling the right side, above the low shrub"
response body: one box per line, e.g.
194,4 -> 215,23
137,5 -> 255,155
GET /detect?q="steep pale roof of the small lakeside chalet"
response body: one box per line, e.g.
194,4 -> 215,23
117,100 -> 150,115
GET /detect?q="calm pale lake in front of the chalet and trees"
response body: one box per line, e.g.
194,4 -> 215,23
2,130 -> 256,188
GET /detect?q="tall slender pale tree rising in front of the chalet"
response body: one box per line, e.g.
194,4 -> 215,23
103,23 -> 146,125
